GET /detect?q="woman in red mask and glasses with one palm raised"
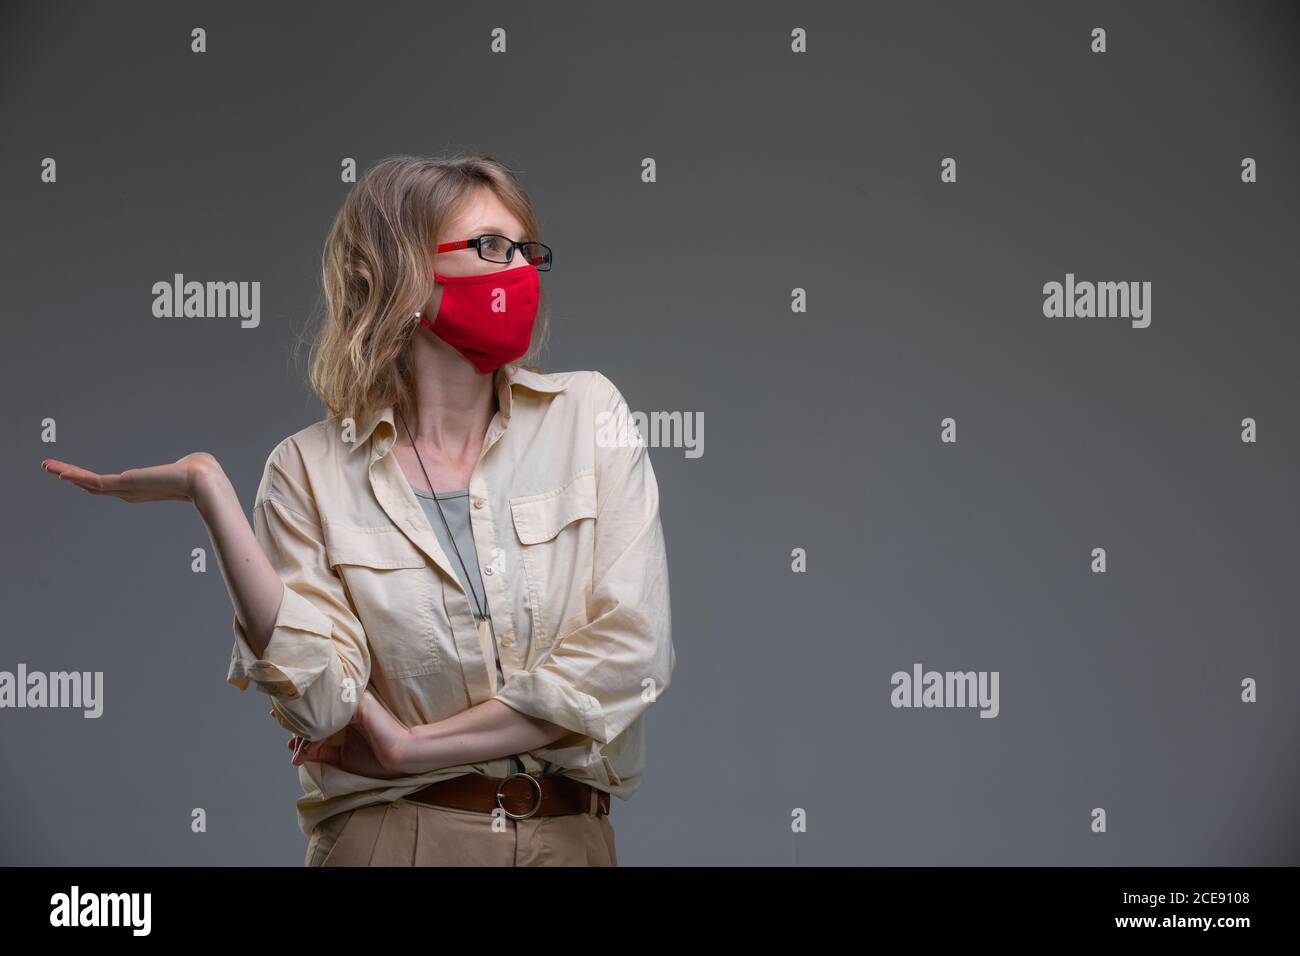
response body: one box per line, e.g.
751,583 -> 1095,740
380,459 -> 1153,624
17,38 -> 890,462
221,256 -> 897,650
43,156 -> 675,866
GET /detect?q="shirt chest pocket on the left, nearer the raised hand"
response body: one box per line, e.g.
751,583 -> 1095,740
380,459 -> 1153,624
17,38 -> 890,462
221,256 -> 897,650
324,524 -> 441,679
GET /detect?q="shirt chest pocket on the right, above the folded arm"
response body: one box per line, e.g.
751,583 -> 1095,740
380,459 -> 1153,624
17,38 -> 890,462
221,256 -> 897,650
510,468 -> 597,646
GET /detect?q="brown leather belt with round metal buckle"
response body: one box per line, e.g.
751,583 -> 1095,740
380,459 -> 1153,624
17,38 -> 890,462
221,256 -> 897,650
400,773 -> 610,819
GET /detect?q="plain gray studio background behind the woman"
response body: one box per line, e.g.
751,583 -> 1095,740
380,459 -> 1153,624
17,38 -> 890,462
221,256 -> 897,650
0,1 -> 1300,866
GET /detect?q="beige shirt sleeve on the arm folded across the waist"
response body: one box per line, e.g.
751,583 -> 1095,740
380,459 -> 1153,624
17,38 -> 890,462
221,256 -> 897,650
497,372 -> 675,745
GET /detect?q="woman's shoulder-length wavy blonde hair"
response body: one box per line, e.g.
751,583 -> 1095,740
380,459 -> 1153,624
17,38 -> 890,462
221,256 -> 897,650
308,156 -> 550,423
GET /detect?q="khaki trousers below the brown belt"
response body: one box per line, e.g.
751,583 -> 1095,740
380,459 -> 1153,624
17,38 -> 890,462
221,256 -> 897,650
303,800 -> 619,866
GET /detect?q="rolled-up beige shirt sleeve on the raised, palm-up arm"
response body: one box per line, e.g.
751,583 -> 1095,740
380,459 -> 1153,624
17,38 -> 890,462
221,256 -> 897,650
226,441 -> 371,740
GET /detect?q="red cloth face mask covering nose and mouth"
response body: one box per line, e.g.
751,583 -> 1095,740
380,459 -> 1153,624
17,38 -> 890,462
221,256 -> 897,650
420,265 -> 541,372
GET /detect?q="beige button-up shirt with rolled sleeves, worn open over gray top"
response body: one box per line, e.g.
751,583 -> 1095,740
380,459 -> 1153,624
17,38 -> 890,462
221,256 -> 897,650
226,365 -> 675,834
